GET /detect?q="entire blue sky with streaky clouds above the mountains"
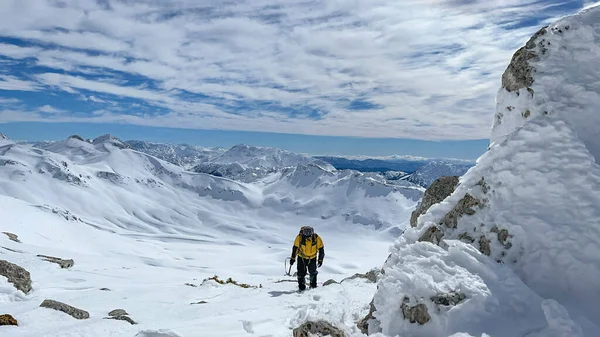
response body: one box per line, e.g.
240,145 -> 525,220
0,0 -> 592,159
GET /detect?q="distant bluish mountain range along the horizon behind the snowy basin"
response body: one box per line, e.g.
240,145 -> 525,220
15,135 -> 474,187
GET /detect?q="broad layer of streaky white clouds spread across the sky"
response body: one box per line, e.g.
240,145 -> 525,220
0,0 -> 584,139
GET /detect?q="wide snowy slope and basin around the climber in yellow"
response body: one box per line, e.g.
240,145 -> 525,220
0,133 -> 422,337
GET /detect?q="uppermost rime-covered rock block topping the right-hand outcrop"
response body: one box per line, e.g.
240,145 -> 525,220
491,7 -> 600,162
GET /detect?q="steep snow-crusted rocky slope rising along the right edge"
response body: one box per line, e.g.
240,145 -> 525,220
369,7 -> 600,337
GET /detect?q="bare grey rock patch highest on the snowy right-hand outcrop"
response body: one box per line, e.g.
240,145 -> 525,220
502,26 -> 548,91
